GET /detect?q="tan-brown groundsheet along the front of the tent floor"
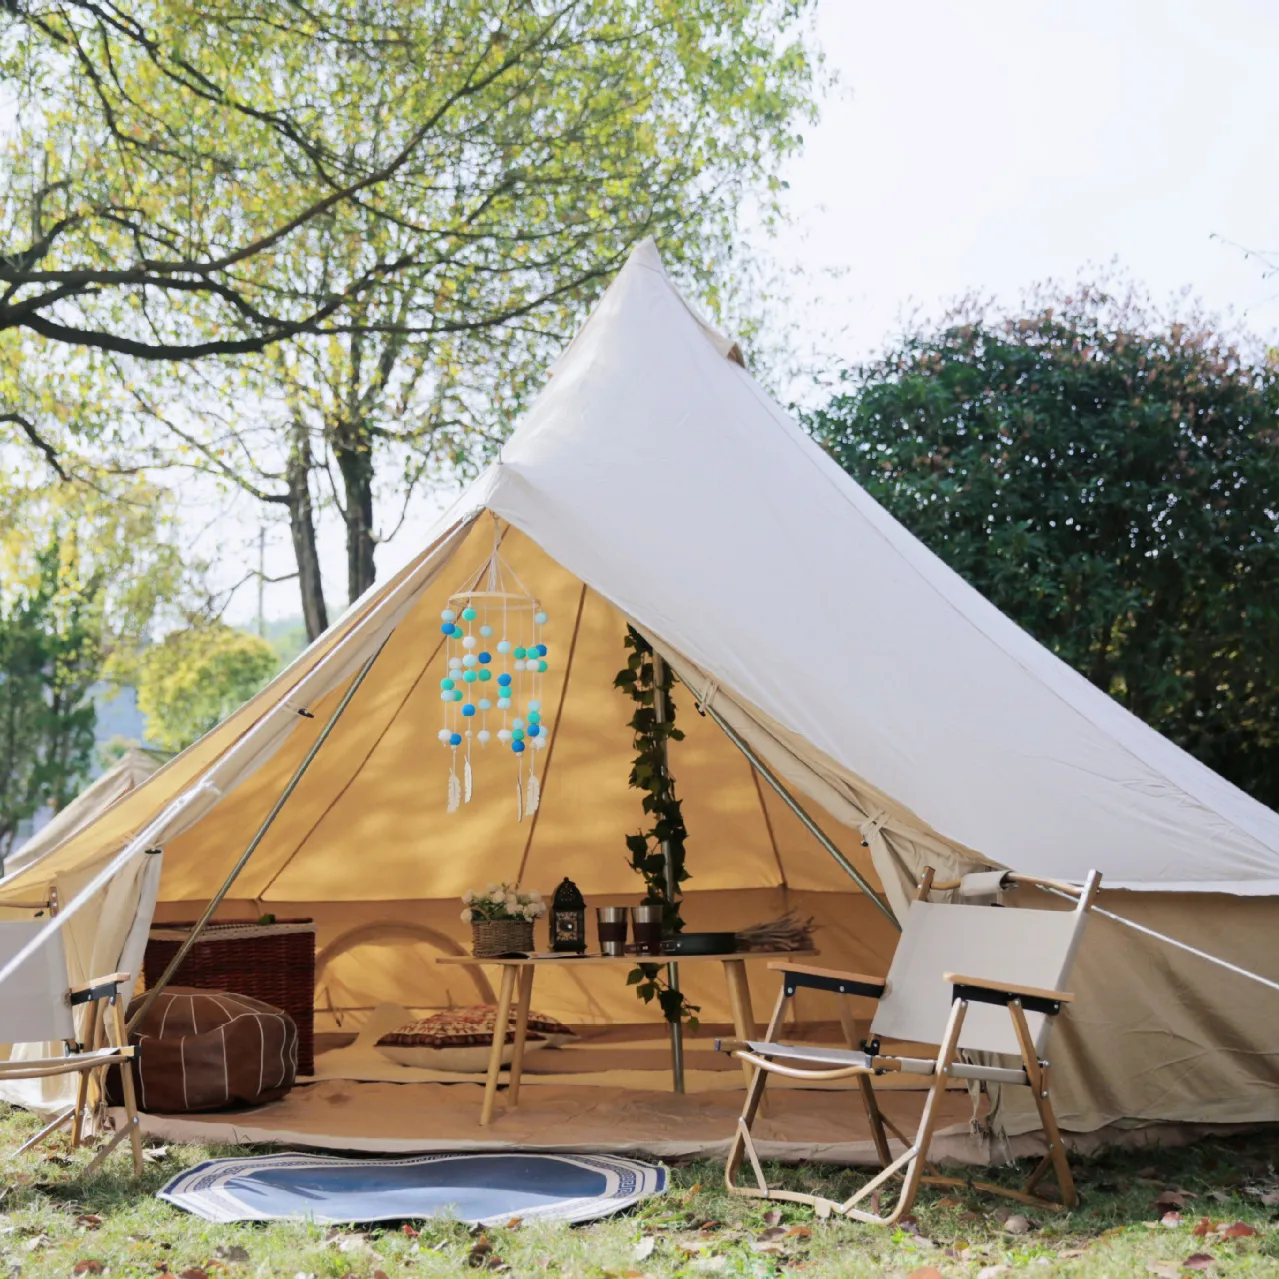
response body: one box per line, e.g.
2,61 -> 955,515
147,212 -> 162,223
117,1081 -> 987,1164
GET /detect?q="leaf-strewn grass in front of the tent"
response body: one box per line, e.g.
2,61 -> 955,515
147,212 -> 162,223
0,1105 -> 1279,1279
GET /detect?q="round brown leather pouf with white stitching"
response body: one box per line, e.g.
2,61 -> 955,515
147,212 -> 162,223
122,986 -> 298,1114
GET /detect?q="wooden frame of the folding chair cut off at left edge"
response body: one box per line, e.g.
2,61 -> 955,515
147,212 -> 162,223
0,972 -> 142,1175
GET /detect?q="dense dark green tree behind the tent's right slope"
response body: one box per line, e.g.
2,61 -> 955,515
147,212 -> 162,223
808,288 -> 1279,807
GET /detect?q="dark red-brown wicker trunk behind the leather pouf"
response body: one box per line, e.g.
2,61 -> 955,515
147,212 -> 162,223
142,920 -> 316,1074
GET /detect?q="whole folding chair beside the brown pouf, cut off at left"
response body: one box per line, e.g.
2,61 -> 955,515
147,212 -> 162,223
0,920 -> 142,1174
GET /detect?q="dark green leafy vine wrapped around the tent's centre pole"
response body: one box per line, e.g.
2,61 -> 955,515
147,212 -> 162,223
613,627 -> 698,1030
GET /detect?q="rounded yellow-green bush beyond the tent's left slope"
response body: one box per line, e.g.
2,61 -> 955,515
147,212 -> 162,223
134,622 -> 279,751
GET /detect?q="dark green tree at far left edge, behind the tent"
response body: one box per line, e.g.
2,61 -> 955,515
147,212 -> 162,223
0,537 -> 102,859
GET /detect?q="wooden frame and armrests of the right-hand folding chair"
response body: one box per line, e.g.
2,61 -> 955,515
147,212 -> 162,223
718,867 -> 1100,1225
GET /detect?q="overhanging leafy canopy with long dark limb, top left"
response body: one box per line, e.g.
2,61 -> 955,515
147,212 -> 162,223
0,0 -> 811,359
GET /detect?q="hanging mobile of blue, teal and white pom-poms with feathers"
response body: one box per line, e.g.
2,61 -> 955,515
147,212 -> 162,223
439,544 -> 550,821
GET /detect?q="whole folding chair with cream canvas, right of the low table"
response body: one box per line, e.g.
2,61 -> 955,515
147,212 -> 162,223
720,868 -> 1101,1225
